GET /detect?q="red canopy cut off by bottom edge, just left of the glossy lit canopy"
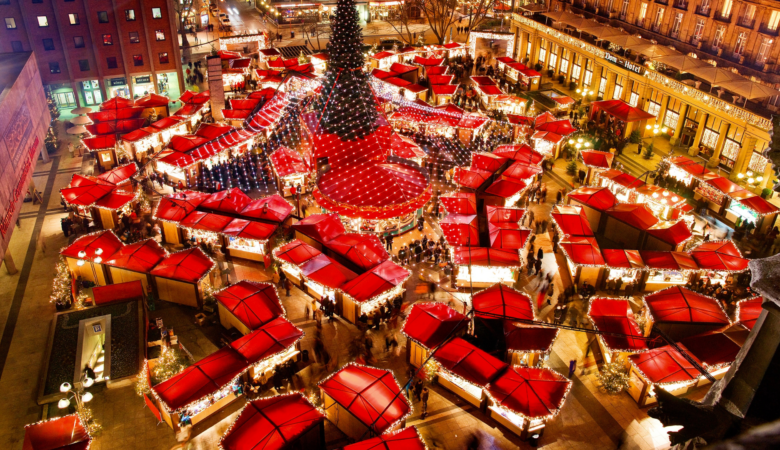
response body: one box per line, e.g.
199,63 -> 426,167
219,392 -> 325,450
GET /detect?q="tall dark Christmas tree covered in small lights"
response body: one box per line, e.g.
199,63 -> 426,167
314,0 -> 378,141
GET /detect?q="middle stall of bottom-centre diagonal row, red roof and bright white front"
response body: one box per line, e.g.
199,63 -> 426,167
433,337 -> 509,409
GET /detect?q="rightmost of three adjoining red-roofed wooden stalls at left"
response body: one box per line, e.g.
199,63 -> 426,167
150,248 -> 222,308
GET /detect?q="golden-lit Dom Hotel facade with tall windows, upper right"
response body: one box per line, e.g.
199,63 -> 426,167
512,0 -> 780,193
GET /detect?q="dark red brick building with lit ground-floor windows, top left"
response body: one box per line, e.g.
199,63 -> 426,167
0,0 -> 184,108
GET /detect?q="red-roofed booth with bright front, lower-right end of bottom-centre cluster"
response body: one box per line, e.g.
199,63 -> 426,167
485,366 -> 572,439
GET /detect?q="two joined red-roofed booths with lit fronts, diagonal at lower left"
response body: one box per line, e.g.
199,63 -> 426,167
151,317 -> 303,432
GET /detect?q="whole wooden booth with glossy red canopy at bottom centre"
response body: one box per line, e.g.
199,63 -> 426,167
319,363 -> 412,440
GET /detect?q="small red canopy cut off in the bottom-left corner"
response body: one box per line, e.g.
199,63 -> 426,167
22,414 -> 92,450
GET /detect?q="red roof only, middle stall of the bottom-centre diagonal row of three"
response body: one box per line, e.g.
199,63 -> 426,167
433,338 -> 509,387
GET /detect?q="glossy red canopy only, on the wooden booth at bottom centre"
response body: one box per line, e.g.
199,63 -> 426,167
319,363 -> 412,434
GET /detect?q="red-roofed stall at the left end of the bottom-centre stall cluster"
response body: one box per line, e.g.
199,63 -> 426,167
401,302 -> 468,367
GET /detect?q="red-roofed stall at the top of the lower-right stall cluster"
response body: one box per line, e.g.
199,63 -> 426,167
643,286 -> 731,341
